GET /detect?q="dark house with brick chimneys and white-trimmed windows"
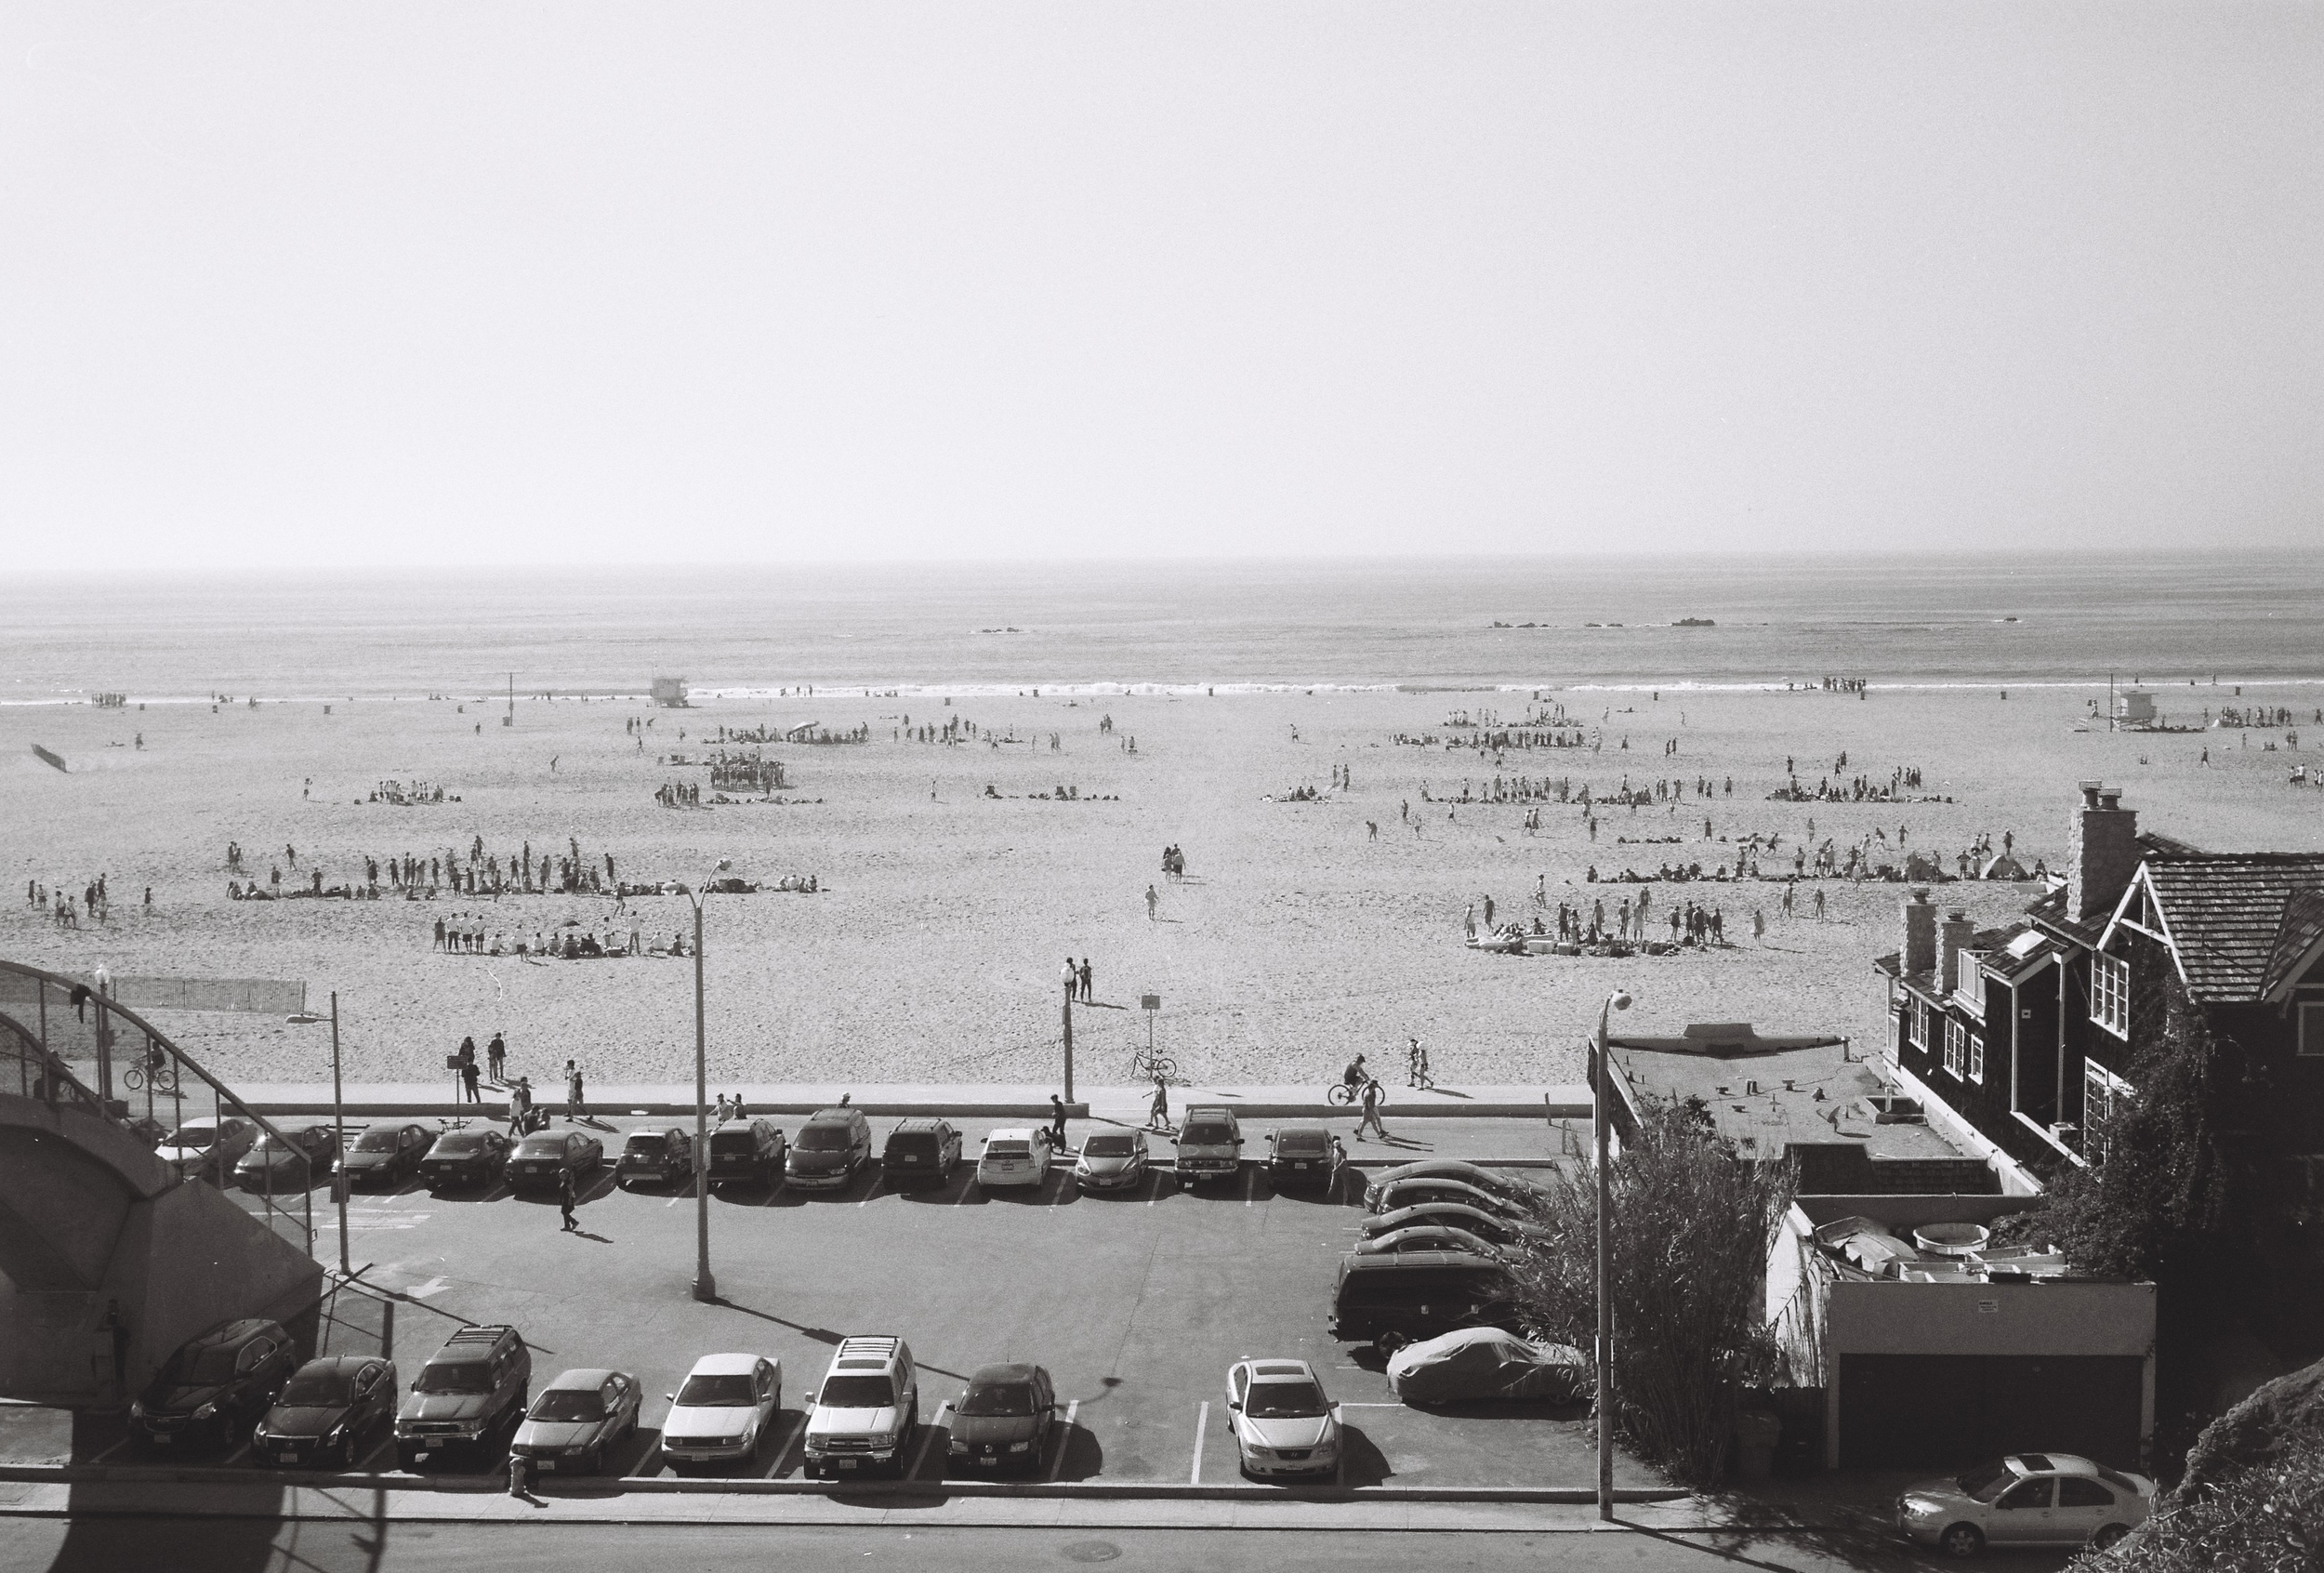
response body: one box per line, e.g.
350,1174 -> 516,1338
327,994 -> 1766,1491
1876,781 -> 2324,1306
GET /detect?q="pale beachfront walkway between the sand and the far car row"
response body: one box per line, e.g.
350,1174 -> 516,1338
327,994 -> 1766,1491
235,1066 -> 1590,1125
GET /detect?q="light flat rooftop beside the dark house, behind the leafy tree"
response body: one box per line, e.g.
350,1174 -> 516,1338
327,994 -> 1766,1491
1606,1023 -> 1969,1157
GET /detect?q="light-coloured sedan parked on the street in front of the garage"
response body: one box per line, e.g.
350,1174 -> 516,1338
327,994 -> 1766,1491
1896,1452 -> 2155,1557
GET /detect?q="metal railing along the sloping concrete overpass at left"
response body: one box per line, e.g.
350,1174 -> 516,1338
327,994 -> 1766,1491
0,959 -> 318,1255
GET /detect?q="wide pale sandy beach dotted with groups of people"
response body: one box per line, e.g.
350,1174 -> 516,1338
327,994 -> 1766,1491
0,688 -> 2324,1088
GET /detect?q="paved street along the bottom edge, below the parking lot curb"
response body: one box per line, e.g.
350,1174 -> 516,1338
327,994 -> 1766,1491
0,1520 -> 2064,1573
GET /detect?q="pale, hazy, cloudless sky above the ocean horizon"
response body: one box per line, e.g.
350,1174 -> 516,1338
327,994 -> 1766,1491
0,0 -> 2324,574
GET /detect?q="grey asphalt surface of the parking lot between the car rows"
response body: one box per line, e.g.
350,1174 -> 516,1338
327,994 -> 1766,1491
122,1120 -> 1655,1487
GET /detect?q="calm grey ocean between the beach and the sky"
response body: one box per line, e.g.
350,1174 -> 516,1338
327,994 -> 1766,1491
0,553 -> 2324,704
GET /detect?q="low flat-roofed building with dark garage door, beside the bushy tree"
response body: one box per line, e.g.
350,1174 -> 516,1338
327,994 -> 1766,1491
1606,1023 -> 2155,1469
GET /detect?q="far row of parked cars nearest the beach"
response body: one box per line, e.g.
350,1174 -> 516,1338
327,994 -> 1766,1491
158,1106 -> 1376,1192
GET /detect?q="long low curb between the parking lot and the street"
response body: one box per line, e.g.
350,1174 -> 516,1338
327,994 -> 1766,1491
0,1464 -> 1692,1506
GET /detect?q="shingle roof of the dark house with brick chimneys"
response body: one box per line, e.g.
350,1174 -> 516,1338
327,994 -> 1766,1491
2146,853 -> 2324,1004
